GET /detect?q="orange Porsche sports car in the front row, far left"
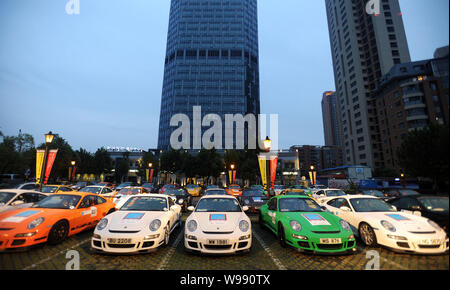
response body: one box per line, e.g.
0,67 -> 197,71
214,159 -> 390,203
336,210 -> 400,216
0,191 -> 115,251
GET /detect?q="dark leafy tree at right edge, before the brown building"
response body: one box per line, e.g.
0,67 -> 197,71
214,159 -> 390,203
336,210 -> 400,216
397,124 -> 449,190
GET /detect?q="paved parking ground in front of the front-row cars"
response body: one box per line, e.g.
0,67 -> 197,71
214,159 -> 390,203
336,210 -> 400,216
0,214 -> 449,270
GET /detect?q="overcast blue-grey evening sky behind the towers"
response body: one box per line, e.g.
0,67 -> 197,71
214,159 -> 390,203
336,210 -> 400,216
0,0 -> 449,152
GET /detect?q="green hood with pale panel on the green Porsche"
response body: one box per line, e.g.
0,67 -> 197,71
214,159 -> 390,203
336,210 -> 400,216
284,212 -> 342,232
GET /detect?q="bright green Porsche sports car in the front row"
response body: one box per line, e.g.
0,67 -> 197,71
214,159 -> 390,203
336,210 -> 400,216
259,195 -> 356,254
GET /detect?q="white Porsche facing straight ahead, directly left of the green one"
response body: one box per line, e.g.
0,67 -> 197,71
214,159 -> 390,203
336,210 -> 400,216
184,195 -> 252,254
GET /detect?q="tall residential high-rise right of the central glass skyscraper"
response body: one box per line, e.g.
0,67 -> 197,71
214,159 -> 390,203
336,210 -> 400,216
325,0 -> 410,168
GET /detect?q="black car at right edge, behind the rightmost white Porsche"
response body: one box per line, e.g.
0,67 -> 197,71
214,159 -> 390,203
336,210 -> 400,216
388,195 -> 449,235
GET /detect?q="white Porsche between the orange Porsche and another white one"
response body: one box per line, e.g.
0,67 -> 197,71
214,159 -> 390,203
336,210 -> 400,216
91,194 -> 181,254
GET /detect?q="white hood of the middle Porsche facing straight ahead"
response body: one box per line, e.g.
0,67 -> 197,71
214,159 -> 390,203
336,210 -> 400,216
192,212 -> 248,232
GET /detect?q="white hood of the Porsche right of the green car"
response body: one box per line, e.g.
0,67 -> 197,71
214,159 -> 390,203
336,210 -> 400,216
359,212 -> 436,232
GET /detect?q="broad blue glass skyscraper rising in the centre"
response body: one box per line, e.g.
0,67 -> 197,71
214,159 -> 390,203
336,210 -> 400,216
158,0 -> 260,150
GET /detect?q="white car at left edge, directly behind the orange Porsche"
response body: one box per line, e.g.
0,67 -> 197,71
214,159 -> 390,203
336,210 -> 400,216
0,189 -> 48,212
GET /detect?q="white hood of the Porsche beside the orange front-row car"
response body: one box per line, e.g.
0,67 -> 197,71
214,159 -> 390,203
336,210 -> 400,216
107,210 -> 167,231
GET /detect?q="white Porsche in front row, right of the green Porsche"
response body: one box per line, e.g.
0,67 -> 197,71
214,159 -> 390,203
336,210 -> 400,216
322,195 -> 449,254
